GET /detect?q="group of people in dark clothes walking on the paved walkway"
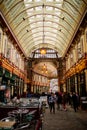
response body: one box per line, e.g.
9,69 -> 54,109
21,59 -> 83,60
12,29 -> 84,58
47,92 -> 80,113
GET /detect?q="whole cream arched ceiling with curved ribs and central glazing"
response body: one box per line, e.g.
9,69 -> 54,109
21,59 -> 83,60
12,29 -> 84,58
0,0 -> 87,57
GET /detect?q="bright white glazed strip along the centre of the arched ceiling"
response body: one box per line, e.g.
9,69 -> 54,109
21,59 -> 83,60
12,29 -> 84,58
24,0 -> 63,52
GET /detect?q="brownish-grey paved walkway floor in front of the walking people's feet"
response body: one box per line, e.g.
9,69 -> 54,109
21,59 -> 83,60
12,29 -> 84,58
43,106 -> 87,130
